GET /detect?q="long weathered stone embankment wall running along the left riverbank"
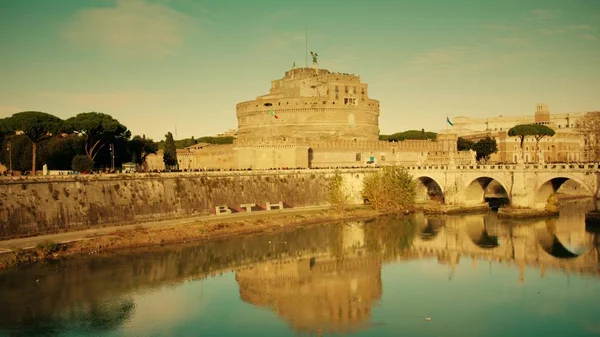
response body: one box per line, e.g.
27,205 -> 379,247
0,170 -> 367,240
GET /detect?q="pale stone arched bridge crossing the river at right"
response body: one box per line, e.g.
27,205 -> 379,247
400,163 -> 600,209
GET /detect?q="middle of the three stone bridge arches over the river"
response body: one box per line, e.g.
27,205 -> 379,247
462,174 -> 511,205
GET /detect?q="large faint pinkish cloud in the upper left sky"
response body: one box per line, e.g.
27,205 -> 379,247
62,0 -> 195,57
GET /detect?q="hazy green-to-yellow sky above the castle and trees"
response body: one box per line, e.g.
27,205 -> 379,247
0,0 -> 600,140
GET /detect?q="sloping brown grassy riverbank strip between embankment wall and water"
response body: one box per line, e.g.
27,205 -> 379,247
0,206 -> 392,269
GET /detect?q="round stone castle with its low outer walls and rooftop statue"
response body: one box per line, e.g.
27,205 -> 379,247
147,59 -> 474,170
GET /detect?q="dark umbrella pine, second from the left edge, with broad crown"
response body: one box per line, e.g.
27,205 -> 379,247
65,112 -> 131,161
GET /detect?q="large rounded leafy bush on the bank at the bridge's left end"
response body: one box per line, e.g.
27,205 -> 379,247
362,166 -> 416,211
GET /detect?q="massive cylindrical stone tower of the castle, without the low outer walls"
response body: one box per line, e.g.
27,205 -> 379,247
236,68 -> 379,144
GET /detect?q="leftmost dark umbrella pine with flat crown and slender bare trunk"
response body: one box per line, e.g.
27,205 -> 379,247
0,111 -> 63,175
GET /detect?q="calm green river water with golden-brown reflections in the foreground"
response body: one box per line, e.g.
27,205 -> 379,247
0,204 -> 600,337
